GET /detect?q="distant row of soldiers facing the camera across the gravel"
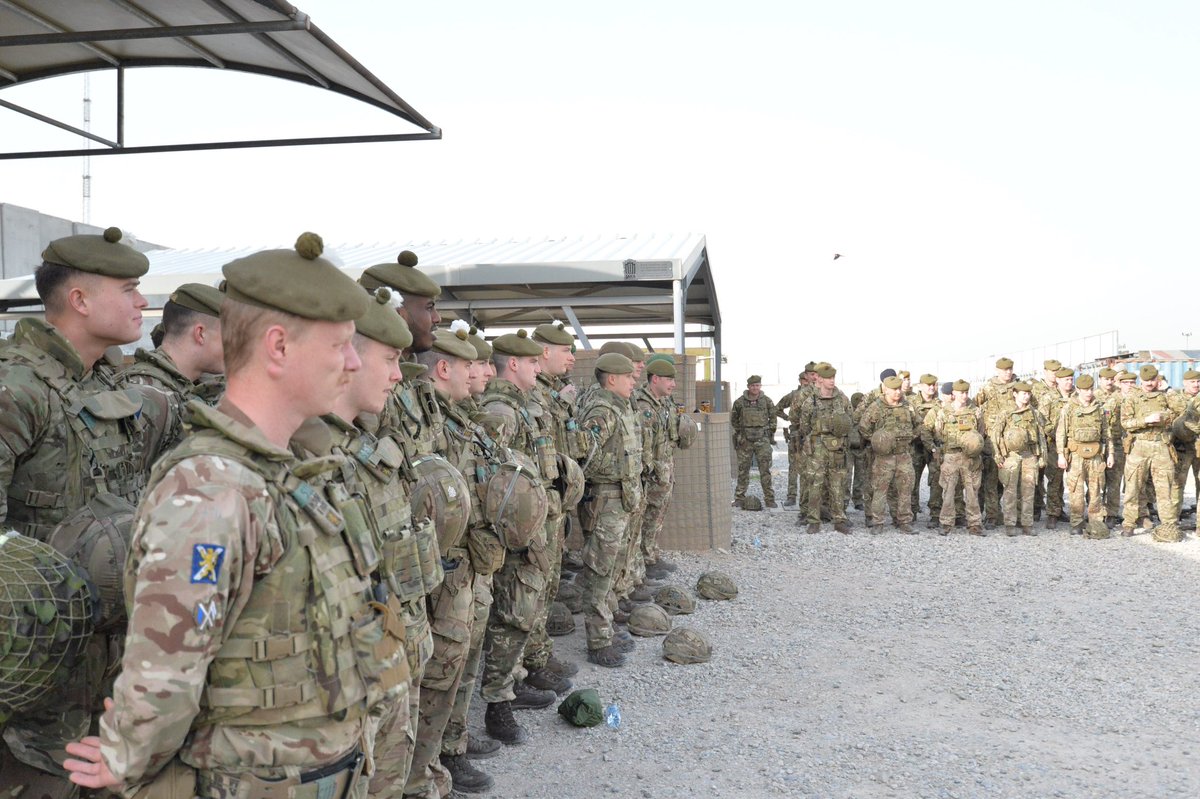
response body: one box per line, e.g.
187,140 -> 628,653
732,358 -> 1200,541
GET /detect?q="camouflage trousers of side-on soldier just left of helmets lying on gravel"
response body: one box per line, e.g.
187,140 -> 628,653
577,489 -> 630,650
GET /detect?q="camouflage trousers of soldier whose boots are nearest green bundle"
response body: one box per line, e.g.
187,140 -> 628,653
479,543 -> 546,704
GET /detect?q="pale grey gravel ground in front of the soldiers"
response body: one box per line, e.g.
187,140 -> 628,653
473,443 -> 1200,799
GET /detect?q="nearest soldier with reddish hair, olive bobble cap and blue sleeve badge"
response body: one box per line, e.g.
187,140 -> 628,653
66,234 -> 388,799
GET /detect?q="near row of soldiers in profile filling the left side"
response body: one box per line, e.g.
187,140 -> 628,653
0,228 -> 695,799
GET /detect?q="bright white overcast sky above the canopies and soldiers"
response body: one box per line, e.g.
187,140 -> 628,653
0,0 -> 1200,390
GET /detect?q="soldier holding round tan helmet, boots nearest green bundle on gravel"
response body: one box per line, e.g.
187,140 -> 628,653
480,329 -> 557,744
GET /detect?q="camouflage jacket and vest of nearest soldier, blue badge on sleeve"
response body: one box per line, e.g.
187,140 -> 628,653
100,402 -> 393,793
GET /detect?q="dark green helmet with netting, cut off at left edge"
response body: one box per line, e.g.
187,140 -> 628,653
0,533 -> 100,725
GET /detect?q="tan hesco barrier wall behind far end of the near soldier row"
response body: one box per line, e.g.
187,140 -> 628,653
659,414 -> 733,552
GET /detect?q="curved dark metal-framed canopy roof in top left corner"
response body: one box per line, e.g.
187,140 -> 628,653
0,0 -> 442,160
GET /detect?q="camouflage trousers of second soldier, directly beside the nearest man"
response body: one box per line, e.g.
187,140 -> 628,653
368,596 -> 433,798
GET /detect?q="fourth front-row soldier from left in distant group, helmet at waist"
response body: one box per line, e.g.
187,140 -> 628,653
922,380 -> 985,535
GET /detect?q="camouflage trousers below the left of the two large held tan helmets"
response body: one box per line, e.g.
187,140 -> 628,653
404,549 -> 475,799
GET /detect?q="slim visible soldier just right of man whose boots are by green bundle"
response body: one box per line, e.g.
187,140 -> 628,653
524,322 -> 587,693
